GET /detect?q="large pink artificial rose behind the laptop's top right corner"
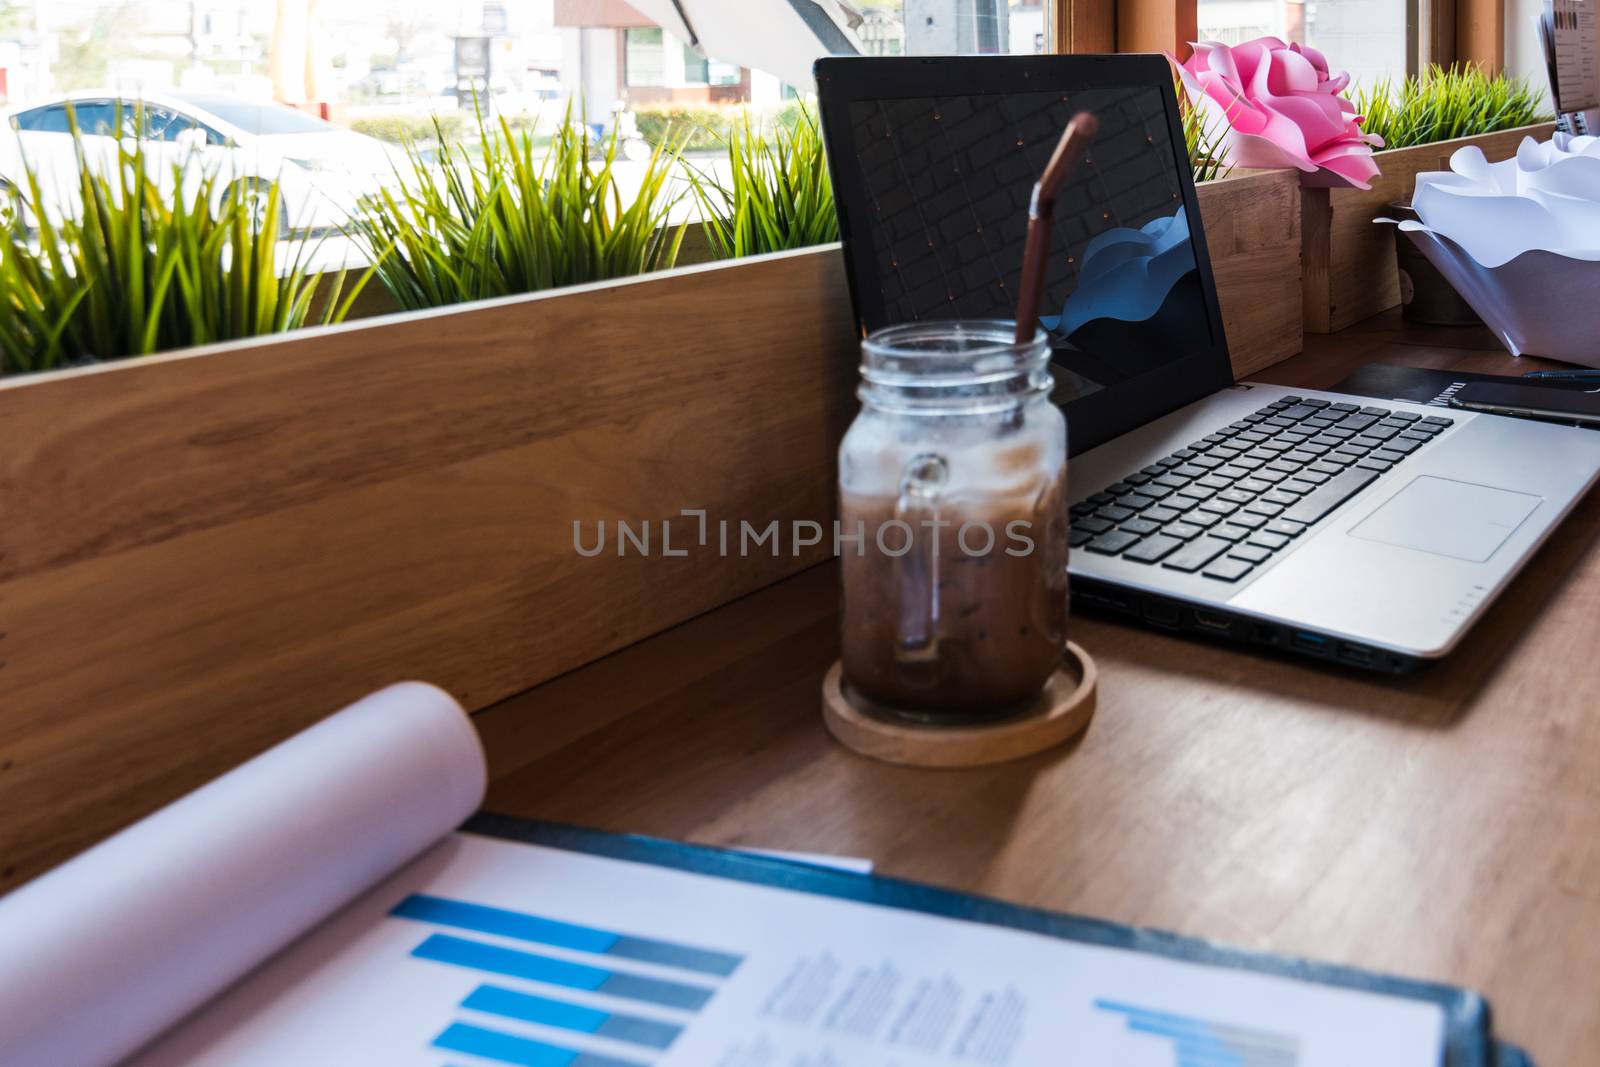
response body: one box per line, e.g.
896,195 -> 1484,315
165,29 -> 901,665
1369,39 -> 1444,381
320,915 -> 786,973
1178,37 -> 1384,189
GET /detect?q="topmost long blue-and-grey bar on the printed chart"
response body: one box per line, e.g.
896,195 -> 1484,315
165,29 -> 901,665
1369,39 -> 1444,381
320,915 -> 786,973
390,894 -> 744,977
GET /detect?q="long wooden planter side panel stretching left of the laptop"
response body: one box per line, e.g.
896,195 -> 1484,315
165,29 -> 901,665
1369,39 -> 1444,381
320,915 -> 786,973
0,246 -> 856,889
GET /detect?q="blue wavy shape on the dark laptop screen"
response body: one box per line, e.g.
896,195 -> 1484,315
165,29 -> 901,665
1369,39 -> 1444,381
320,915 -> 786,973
1040,208 -> 1195,338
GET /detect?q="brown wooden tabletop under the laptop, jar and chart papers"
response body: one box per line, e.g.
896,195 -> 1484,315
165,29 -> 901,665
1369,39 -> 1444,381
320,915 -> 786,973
478,312 -> 1600,1067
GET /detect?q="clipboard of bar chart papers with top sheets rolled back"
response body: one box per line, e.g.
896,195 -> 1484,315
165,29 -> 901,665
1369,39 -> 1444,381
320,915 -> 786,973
0,686 -> 1493,1067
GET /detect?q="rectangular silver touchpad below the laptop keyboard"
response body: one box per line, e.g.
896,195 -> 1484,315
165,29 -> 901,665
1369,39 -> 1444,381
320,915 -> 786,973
1350,475 -> 1544,563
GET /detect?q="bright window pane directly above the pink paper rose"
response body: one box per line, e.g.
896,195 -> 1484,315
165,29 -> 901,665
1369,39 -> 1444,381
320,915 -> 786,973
1198,0 -> 1411,83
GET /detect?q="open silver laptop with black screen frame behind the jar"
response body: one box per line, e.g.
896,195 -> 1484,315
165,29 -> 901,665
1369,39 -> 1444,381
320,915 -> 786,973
816,54 -> 1600,673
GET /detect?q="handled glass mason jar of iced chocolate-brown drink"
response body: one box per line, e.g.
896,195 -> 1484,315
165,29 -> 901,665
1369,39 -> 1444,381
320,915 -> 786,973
838,320 -> 1067,721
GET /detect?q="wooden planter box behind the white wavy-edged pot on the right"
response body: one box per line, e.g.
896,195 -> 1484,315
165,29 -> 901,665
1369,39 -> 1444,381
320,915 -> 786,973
1301,123 -> 1555,333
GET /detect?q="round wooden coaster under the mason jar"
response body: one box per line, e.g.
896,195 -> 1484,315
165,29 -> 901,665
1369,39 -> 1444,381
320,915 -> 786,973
822,641 -> 1098,766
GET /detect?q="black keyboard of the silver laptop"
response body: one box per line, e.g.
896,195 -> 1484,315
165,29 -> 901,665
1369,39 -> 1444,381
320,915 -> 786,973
1070,397 -> 1454,582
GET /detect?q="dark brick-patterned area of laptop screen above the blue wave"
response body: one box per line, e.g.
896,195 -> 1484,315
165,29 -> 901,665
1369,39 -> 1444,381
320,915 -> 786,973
851,90 -> 1182,323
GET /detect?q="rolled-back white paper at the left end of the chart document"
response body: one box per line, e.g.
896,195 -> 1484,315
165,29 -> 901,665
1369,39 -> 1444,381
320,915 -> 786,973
0,681 -> 486,1067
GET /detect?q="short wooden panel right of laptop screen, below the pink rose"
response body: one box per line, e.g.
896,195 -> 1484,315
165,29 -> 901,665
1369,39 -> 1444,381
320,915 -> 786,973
1195,170 -> 1302,378
